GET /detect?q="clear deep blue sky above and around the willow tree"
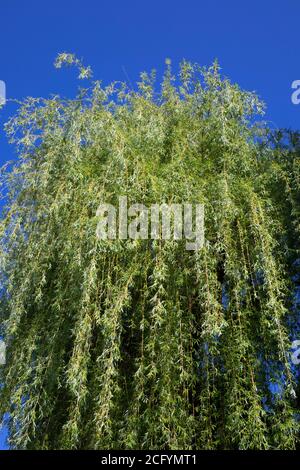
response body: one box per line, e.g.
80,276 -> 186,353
0,0 -> 300,449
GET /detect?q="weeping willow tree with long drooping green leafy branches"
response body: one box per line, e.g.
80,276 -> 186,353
0,54 -> 297,449
